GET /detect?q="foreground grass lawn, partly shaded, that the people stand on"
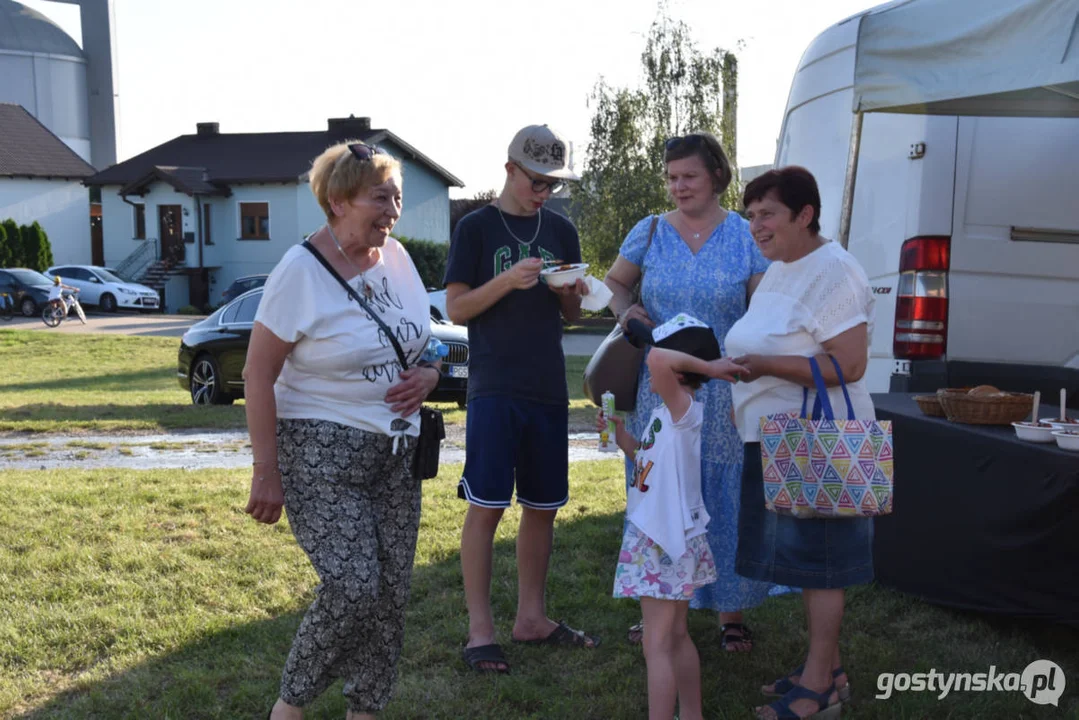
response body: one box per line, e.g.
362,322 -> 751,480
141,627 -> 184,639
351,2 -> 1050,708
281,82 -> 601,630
0,461 -> 1079,720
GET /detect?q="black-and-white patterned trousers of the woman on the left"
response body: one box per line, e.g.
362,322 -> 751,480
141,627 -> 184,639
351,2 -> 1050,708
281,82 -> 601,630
277,419 -> 421,712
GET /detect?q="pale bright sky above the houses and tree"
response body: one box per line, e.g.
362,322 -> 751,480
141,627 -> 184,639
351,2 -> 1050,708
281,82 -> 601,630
19,0 -> 879,198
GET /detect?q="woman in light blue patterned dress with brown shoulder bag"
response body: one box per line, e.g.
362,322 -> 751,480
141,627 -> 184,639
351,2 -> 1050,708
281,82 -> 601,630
604,133 -> 786,651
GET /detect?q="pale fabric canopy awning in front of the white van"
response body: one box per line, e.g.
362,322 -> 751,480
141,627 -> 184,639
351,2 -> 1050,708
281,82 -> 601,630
853,0 -> 1079,117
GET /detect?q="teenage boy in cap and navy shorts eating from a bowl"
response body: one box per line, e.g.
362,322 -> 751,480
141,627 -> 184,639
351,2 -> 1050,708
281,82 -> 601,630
446,125 -> 599,673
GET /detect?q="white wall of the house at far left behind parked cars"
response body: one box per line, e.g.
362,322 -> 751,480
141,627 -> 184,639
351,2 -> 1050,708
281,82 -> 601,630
0,178 -> 91,264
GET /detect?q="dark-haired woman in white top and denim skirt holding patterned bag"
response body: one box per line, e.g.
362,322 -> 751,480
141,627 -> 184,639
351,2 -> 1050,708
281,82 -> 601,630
726,166 -> 875,718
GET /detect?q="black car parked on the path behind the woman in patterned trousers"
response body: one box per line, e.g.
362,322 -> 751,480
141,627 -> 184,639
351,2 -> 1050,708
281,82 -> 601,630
176,287 -> 468,406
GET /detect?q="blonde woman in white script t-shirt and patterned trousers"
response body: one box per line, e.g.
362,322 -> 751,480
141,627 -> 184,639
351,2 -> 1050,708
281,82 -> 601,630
244,142 -> 439,720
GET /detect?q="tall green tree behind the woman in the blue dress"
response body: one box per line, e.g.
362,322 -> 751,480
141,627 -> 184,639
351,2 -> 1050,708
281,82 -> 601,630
573,1 -> 741,276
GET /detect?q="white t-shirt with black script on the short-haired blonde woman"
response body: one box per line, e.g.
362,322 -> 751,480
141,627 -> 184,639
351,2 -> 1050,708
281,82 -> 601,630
255,237 -> 431,436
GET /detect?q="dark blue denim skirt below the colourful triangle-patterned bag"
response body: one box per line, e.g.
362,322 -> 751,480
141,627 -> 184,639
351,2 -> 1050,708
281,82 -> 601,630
735,443 -> 873,589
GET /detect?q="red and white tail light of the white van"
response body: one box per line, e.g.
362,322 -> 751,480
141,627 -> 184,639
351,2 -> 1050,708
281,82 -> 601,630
892,237 -> 952,359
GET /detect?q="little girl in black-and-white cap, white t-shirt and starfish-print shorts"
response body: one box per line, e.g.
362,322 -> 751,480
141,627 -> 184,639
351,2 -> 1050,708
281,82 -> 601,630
598,314 -> 745,720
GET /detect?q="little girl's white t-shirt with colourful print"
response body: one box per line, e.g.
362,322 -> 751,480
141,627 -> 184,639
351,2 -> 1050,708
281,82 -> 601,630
626,399 -> 711,560
